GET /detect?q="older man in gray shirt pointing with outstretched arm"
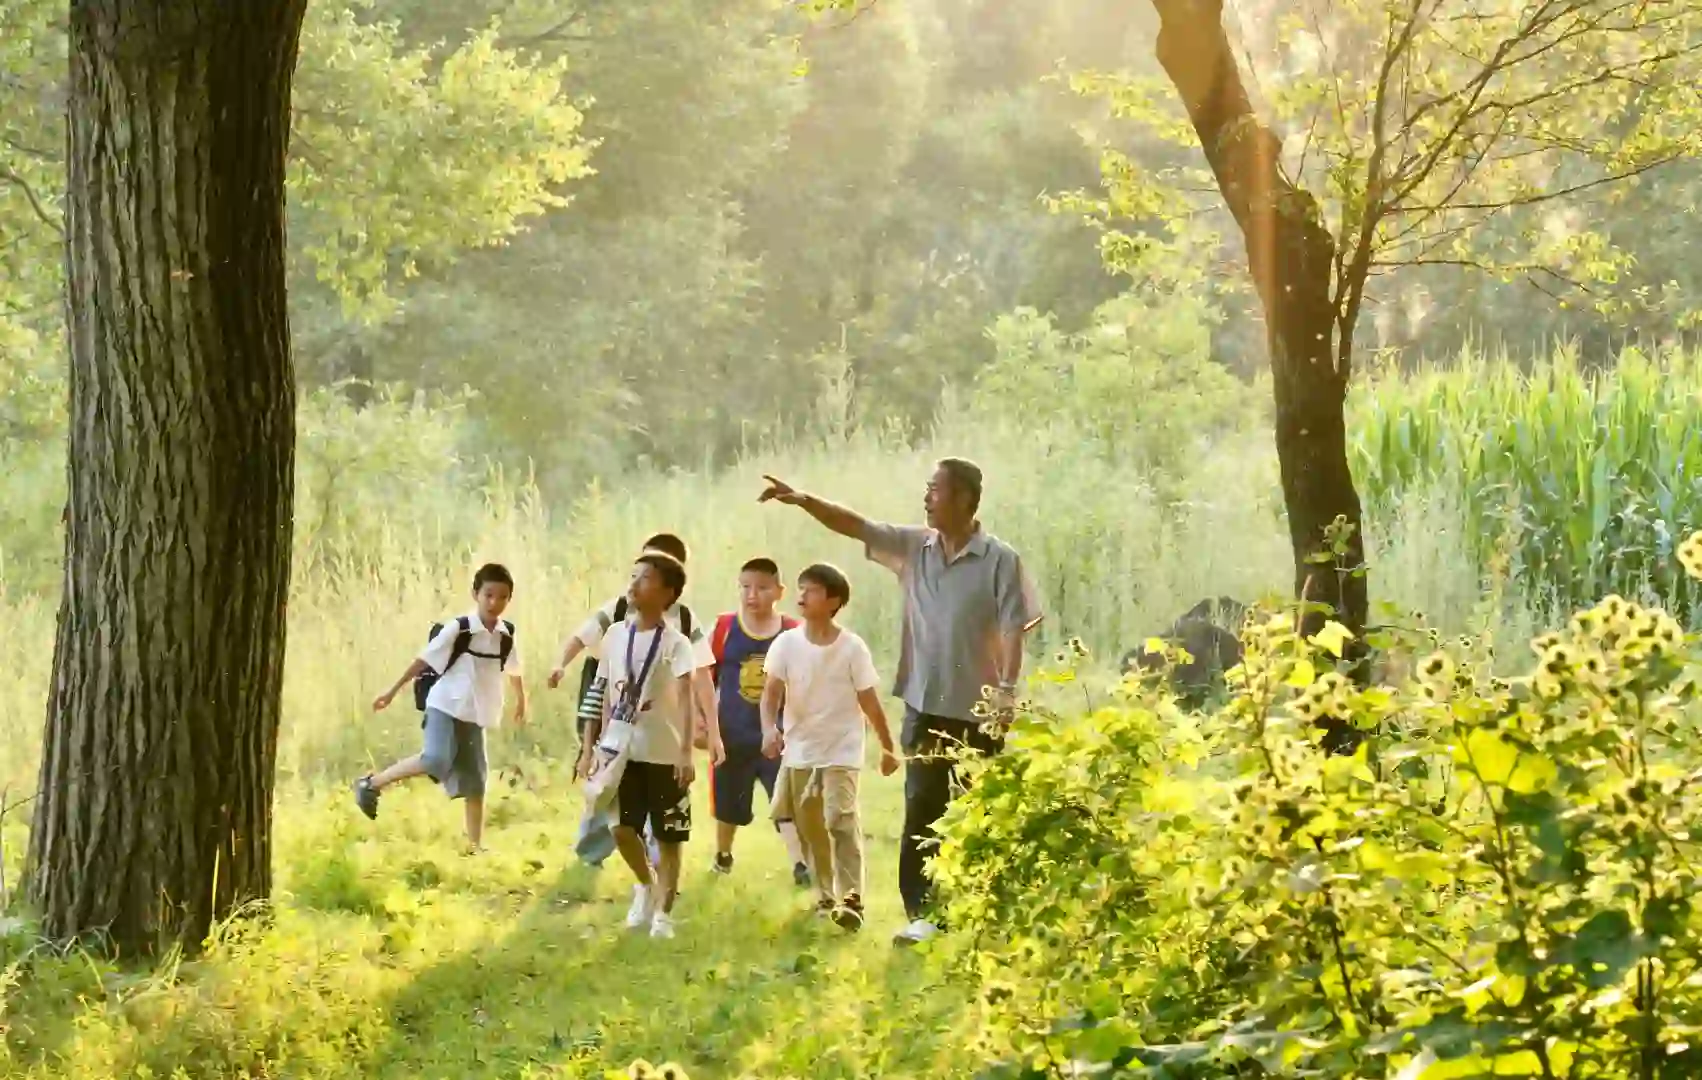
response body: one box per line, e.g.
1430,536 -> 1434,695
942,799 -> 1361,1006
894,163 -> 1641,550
761,458 -> 1040,944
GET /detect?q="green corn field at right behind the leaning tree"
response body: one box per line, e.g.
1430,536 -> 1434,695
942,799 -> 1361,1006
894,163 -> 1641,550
1350,341 -> 1702,622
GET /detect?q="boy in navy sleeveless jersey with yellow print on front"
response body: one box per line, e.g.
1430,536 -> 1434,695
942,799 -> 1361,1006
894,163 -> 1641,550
710,558 -> 810,886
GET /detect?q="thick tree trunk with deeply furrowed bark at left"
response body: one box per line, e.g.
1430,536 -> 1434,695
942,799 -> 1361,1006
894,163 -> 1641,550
29,0 -> 305,952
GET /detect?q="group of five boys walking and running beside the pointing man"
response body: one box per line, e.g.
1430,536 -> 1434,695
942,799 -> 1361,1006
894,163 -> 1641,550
354,534 -> 899,937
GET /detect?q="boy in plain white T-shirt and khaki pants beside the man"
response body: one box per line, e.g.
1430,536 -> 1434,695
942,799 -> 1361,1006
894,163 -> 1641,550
762,563 -> 899,930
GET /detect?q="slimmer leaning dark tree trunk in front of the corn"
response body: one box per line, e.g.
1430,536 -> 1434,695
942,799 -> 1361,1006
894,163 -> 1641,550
1152,0 -> 1367,634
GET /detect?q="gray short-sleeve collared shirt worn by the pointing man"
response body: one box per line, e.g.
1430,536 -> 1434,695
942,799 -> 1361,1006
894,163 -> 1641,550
863,522 -> 1040,721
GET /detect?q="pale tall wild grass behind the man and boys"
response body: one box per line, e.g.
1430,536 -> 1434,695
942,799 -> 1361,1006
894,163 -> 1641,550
0,401 -> 1518,857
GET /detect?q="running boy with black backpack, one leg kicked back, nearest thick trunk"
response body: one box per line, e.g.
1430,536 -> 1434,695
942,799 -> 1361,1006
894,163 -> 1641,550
354,563 -> 526,850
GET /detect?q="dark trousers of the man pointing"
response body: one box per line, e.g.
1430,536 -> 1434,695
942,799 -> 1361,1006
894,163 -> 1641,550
899,708 -> 1004,918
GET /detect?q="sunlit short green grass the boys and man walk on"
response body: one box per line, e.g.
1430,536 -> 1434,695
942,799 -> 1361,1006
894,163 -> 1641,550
0,767 -> 974,1080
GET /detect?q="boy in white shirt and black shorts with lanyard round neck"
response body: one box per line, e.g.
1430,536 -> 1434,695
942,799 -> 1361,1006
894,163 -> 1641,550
579,551 -> 698,937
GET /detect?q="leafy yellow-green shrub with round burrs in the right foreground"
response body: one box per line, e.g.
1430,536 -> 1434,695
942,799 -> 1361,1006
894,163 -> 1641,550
938,534 -> 1702,1080
